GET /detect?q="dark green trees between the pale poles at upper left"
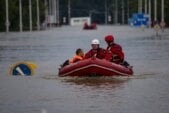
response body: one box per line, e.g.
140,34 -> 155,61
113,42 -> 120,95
0,0 -> 45,31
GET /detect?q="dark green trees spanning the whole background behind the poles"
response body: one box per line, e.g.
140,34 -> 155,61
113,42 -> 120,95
0,0 -> 169,31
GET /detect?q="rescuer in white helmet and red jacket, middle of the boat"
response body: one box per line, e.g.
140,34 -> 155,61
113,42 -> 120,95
84,39 -> 106,59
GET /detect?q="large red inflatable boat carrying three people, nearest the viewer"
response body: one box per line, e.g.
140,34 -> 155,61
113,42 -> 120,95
59,58 -> 133,77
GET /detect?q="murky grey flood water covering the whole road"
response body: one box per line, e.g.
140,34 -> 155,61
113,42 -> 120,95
0,26 -> 169,113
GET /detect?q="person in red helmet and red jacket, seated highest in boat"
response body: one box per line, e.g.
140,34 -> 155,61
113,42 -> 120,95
105,35 -> 129,66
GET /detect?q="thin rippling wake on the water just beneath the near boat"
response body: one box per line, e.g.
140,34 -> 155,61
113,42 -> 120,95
42,72 -> 159,83
